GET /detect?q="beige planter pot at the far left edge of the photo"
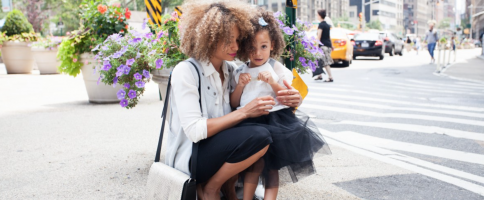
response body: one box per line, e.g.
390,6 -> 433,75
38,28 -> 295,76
2,41 -> 34,74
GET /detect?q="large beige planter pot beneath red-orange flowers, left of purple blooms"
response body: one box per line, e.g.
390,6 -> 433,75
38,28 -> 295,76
78,53 -> 122,103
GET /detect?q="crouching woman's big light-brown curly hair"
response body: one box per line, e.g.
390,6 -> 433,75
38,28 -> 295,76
180,1 -> 255,61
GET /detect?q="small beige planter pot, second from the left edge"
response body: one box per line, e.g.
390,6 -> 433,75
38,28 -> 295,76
32,47 -> 60,74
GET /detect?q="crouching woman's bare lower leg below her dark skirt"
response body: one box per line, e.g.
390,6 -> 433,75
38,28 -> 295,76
200,145 -> 269,200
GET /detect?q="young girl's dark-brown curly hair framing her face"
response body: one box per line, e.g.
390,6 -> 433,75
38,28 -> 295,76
237,9 -> 286,61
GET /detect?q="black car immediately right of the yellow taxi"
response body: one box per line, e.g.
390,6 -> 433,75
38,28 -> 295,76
351,33 -> 385,60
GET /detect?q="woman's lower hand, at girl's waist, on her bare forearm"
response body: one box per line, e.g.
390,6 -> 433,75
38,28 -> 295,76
240,96 -> 276,118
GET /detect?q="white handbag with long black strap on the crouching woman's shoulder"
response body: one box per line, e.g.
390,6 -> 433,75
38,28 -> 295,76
147,61 -> 202,200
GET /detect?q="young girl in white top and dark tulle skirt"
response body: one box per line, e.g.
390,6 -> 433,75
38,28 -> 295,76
230,11 -> 330,200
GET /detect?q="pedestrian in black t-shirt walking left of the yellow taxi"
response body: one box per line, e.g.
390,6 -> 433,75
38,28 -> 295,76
313,9 -> 334,82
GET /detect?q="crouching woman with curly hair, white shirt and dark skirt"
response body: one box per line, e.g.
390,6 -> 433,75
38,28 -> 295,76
165,2 -> 301,200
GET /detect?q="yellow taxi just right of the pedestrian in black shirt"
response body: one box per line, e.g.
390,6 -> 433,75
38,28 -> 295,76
330,28 -> 353,67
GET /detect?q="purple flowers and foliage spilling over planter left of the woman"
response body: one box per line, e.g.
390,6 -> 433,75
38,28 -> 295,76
95,19 -> 187,108
